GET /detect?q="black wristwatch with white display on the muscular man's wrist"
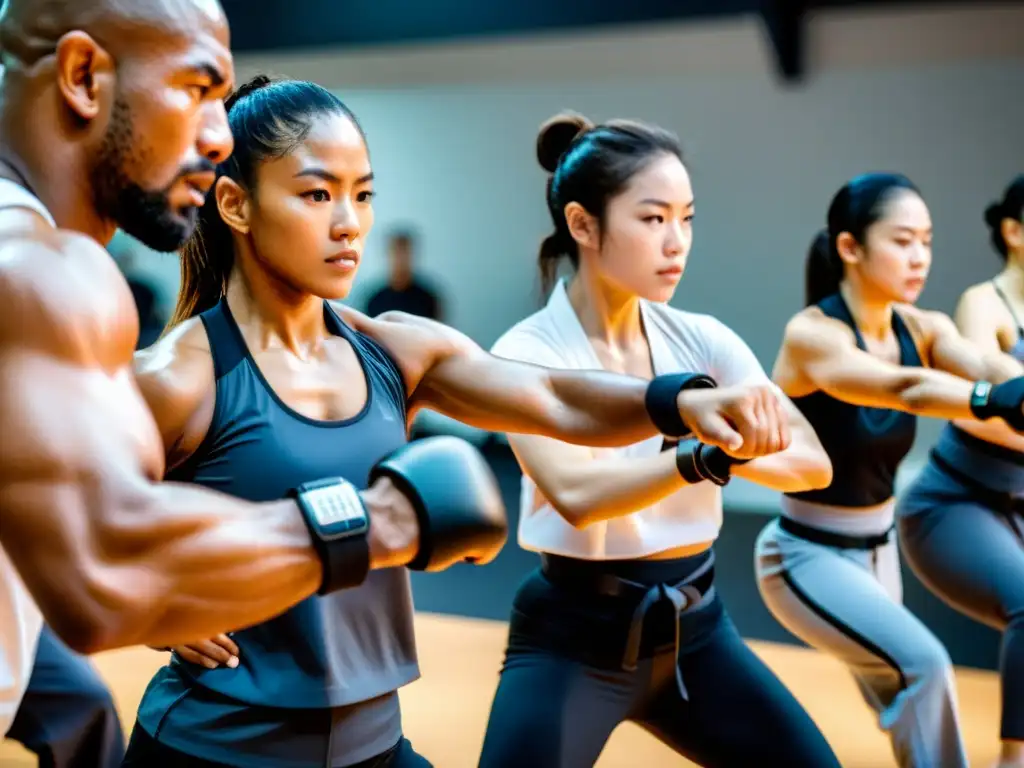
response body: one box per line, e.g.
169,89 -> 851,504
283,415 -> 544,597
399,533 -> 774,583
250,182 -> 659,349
291,477 -> 370,595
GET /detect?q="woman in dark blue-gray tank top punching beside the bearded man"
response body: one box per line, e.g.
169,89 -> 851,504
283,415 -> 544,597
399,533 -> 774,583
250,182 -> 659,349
126,78 -> 784,768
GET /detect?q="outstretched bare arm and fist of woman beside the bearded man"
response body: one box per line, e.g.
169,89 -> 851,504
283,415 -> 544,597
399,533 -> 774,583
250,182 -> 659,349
338,307 -> 788,458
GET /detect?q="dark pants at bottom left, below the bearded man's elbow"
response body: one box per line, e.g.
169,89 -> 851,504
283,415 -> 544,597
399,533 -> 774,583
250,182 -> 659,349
7,627 -> 125,768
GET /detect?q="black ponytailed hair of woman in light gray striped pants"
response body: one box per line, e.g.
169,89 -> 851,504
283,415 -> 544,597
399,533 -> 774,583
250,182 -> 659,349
804,173 -> 920,306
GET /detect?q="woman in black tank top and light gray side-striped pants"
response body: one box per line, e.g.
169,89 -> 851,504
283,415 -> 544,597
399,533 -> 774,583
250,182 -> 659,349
756,173 -> 1024,768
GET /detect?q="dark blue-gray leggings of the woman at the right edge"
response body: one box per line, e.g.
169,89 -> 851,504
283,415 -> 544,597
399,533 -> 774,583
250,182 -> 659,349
898,427 -> 1024,741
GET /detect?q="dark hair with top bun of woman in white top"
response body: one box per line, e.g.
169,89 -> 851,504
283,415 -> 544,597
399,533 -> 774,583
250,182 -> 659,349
537,112 -> 682,294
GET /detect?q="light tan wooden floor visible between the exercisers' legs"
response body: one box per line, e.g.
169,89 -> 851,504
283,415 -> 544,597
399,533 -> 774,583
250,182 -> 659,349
0,614 -> 999,768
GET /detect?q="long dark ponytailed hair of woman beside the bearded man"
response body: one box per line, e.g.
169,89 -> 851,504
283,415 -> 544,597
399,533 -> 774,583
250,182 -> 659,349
168,75 -> 361,328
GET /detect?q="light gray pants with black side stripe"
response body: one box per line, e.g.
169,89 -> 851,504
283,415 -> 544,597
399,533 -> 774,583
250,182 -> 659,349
755,499 -> 968,768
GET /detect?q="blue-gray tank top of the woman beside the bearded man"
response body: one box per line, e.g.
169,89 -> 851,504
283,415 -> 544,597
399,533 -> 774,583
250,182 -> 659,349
161,301 -> 419,709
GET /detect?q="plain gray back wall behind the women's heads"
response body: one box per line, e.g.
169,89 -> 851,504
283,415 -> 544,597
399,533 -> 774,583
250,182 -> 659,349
125,3 -> 1024,456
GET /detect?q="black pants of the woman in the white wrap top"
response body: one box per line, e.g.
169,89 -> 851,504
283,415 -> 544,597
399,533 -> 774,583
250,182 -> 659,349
480,553 -> 839,768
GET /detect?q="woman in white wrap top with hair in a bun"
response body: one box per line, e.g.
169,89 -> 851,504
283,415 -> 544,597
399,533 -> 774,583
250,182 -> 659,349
480,115 -> 839,768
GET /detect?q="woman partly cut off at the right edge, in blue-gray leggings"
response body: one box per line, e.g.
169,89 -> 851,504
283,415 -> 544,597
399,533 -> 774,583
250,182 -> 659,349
897,175 -> 1024,768
